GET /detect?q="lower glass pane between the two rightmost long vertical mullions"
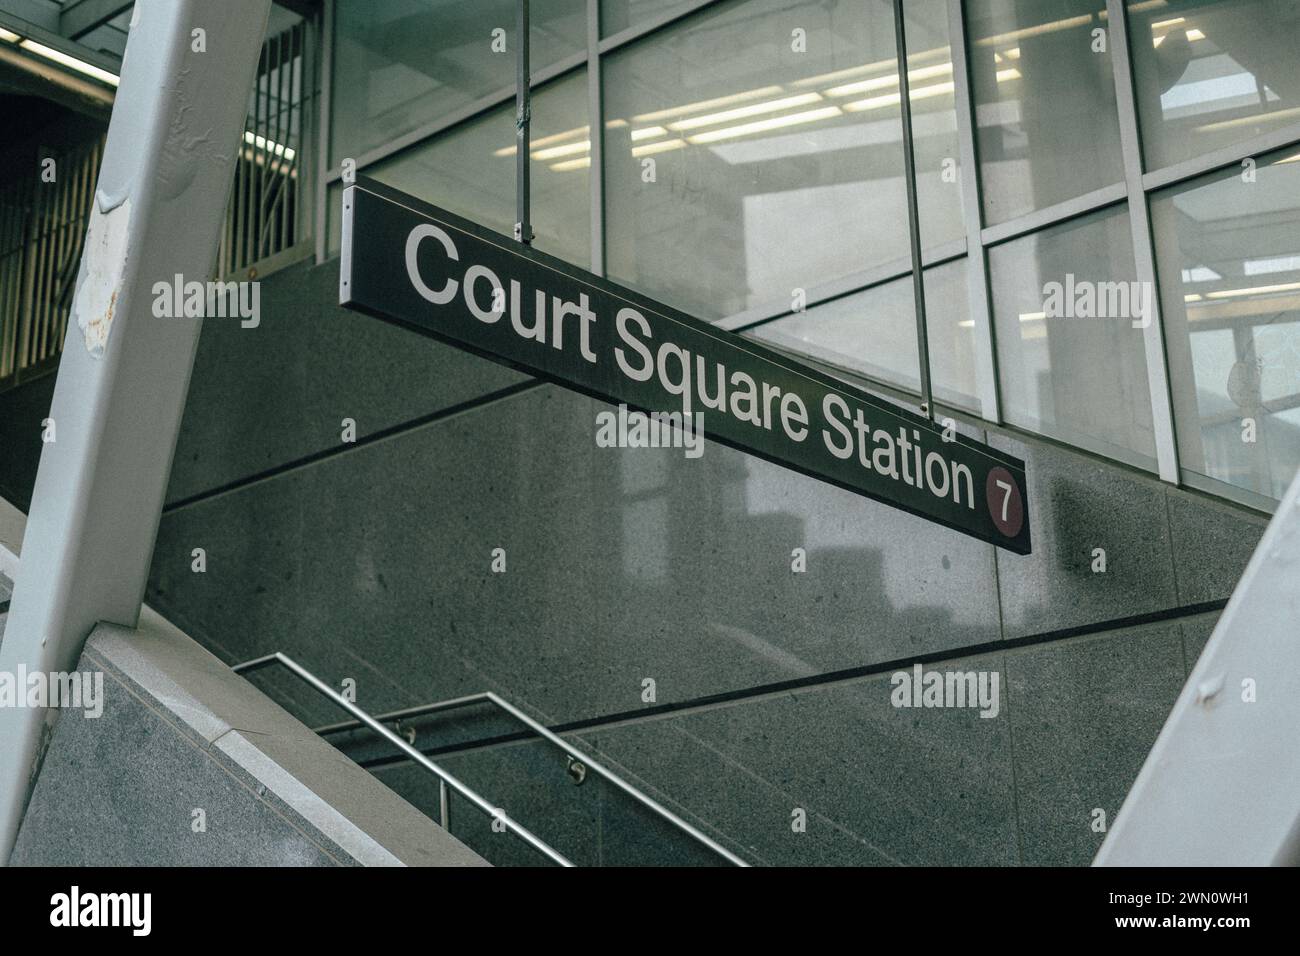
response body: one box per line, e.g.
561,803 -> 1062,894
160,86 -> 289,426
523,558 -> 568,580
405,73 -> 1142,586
989,206 -> 1156,468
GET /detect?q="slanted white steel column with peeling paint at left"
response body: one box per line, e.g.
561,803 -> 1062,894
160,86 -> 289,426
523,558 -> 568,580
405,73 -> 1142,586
0,0 -> 270,861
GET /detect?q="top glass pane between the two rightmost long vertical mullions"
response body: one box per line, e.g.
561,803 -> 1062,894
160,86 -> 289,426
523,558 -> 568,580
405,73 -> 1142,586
966,0 -> 1125,224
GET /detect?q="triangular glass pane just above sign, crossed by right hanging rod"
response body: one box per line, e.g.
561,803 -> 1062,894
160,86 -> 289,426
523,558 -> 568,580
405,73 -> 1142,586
750,259 -> 976,408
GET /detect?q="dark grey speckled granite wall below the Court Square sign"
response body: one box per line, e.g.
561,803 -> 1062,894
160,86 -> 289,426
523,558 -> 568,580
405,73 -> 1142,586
0,256 -> 1264,864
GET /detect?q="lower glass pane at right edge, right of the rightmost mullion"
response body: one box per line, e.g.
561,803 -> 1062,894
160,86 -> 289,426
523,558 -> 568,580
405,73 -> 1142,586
1151,151 -> 1300,498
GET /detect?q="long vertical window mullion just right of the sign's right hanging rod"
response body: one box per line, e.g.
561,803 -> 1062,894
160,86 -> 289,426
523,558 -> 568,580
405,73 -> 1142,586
948,0 -> 1002,424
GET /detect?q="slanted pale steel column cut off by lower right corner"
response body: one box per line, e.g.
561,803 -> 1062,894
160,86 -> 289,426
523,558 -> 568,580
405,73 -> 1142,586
1093,475 -> 1300,866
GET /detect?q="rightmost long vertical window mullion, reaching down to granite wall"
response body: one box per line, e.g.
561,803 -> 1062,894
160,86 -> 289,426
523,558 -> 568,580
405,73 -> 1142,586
1106,0 -> 1179,484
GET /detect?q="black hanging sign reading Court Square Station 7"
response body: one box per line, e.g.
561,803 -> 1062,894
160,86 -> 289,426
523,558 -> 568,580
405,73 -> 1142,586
339,181 -> 1030,554
